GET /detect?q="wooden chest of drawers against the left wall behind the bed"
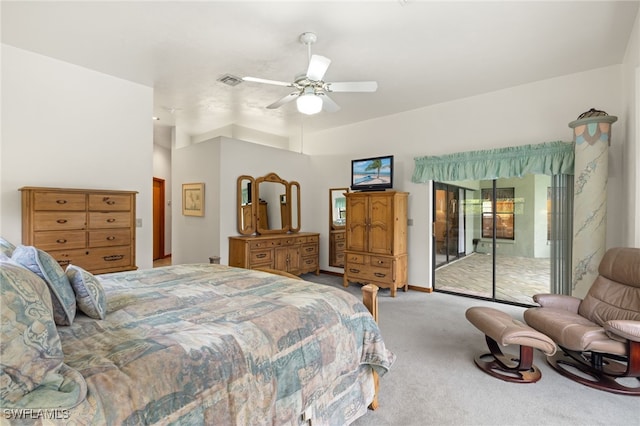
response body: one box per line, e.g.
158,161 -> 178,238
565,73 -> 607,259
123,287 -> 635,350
20,187 -> 137,274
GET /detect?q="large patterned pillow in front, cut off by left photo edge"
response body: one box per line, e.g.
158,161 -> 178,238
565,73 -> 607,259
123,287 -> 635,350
0,260 -> 87,411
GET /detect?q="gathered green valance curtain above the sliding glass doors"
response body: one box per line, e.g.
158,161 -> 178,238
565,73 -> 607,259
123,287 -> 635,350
411,141 -> 575,183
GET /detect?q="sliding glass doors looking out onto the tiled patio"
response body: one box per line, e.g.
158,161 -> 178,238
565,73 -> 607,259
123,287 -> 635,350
433,175 -> 552,305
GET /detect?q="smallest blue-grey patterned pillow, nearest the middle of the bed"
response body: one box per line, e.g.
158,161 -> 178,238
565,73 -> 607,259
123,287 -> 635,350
65,264 -> 107,319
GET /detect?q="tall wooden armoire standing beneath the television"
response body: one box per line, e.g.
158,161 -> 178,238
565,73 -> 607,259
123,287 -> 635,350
343,191 -> 409,297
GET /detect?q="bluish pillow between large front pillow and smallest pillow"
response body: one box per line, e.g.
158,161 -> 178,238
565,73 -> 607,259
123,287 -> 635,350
11,245 -> 76,325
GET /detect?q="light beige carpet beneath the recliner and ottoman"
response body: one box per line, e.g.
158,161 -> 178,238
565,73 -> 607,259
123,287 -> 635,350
303,274 -> 640,426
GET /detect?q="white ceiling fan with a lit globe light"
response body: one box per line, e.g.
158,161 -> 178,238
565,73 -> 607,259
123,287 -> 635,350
242,32 -> 378,115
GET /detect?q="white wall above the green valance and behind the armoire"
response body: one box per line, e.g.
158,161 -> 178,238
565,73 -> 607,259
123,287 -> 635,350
304,66 -> 627,287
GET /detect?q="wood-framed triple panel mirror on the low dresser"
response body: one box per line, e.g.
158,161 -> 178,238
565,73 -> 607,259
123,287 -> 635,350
237,173 -> 300,235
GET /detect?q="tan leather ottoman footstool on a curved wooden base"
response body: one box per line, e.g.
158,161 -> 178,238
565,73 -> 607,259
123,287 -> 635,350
465,306 -> 556,383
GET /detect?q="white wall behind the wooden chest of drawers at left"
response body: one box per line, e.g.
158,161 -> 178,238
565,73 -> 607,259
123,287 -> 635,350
0,45 -> 153,268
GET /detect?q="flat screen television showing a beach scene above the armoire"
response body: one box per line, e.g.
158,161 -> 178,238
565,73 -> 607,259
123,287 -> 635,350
351,155 -> 393,191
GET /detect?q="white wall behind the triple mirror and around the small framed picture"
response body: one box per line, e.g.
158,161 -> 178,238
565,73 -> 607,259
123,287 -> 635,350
172,136 -> 317,264
